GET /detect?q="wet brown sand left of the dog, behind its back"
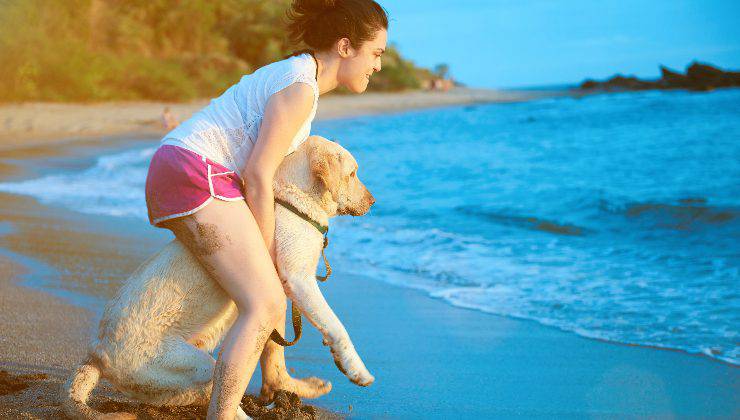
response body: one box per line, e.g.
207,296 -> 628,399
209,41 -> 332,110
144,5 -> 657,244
0,193 -> 337,419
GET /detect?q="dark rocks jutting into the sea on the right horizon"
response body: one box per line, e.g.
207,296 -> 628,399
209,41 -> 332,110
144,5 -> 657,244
579,61 -> 740,92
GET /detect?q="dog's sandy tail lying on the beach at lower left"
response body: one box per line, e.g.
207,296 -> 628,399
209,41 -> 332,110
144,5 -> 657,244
62,356 -> 136,420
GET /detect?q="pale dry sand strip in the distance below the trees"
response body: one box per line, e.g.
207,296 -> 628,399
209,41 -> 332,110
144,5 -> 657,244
0,88 -> 556,151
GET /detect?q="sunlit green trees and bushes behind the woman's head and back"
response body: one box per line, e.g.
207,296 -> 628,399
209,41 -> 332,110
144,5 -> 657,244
0,0 -> 430,102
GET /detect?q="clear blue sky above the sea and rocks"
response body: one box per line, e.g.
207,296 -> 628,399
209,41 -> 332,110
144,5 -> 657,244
378,0 -> 740,88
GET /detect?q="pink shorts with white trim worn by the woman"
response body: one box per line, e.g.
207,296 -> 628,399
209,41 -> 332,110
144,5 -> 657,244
146,144 -> 244,227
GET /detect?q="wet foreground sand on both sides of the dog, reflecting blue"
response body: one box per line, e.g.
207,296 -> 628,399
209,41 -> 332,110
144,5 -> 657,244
0,195 -> 740,418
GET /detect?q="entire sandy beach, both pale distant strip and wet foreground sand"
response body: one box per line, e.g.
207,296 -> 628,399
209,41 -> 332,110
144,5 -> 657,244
0,90 -> 740,418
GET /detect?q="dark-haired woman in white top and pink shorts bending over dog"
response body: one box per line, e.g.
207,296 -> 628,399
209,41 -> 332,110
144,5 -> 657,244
146,0 -> 388,419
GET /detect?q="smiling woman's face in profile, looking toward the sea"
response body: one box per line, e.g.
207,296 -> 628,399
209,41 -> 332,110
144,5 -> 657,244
337,29 -> 388,93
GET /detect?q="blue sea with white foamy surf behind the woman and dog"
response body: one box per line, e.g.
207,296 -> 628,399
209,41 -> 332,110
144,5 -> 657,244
0,90 -> 740,364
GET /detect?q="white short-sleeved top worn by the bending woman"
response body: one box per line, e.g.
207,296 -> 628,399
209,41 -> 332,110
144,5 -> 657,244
161,53 -> 319,174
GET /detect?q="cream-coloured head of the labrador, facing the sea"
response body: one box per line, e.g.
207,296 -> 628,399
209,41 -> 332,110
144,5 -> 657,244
275,136 -> 375,217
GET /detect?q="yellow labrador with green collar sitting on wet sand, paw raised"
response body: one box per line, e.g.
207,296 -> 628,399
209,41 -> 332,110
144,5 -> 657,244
64,136 -> 375,418
